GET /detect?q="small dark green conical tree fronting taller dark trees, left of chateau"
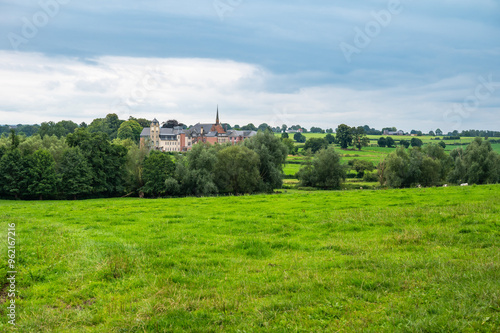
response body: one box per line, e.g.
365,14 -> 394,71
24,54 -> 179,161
58,147 -> 92,200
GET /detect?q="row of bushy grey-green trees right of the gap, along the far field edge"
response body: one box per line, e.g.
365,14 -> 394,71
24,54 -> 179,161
297,138 -> 500,189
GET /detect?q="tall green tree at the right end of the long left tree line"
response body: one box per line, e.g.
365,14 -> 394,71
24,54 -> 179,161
243,131 -> 288,192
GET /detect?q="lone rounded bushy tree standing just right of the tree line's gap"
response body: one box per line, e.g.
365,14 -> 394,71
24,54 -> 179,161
297,146 -> 346,189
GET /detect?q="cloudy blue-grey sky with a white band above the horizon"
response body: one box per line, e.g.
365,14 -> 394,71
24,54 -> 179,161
0,0 -> 500,132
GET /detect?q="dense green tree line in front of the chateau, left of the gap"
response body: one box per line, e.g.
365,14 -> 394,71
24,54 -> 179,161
0,127 -> 288,199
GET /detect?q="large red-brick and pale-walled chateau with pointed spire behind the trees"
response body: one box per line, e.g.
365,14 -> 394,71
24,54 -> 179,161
141,108 -> 257,152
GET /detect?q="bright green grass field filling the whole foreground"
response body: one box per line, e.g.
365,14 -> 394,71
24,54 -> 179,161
0,186 -> 500,332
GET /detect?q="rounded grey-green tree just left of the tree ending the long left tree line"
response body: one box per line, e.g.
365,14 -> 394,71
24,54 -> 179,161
215,145 -> 260,195
